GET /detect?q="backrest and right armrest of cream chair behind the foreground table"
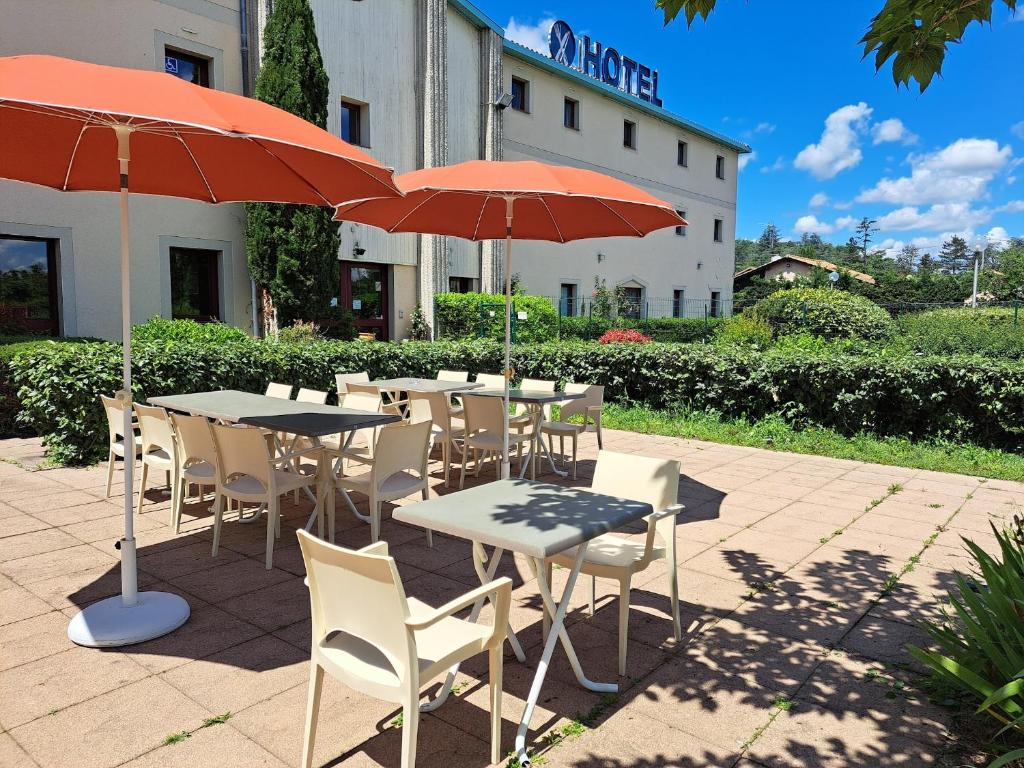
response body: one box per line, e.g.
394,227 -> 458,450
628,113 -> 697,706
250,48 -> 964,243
590,451 -> 680,562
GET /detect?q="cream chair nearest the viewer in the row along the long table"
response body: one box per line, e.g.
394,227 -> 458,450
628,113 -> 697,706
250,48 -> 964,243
211,424 -> 322,570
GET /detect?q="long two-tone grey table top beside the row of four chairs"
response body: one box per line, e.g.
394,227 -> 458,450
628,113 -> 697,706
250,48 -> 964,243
148,389 -> 401,437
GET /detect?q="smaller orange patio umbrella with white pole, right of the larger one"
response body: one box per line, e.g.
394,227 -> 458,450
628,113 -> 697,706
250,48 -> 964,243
335,160 -> 686,477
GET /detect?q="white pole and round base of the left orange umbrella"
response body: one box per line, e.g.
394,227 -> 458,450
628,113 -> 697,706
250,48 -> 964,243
68,125 -> 190,648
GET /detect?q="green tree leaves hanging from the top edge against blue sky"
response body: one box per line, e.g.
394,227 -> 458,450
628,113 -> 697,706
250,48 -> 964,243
655,0 -> 1017,92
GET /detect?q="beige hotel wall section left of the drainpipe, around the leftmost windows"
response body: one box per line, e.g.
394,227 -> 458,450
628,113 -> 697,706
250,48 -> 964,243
0,0 -> 251,339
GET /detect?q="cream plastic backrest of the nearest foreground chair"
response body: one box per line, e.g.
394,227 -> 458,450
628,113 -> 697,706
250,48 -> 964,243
298,528 -> 416,682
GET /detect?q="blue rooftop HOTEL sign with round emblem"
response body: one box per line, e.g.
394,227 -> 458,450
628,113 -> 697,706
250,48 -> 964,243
549,20 -> 662,106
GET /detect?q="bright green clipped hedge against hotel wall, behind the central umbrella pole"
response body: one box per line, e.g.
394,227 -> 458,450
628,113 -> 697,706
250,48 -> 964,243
434,293 -> 558,344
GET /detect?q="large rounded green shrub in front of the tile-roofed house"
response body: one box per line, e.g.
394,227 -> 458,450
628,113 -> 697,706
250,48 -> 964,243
750,288 -> 894,340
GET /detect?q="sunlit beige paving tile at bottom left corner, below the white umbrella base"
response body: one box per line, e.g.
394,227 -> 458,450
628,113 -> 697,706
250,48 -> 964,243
11,677 -> 212,768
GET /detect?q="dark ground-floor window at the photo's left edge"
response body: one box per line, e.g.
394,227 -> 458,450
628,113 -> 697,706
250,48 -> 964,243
0,236 -> 60,336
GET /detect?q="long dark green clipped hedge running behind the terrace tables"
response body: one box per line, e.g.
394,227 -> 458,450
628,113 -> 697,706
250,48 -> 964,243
11,341 -> 1024,462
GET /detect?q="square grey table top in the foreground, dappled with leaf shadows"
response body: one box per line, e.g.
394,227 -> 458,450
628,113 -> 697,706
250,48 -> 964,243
392,479 -> 653,557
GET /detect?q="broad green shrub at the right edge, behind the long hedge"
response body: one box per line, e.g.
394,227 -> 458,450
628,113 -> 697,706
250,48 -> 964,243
897,308 -> 1024,359
